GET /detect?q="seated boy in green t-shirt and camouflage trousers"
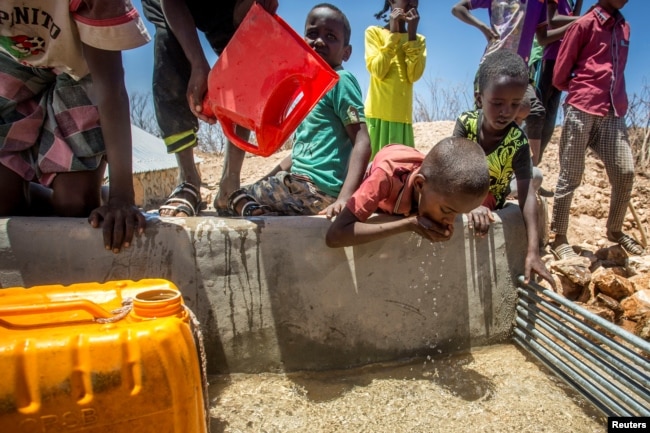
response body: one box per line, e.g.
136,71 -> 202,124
228,3 -> 370,217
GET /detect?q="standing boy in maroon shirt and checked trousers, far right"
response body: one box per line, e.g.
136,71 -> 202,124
551,0 -> 643,259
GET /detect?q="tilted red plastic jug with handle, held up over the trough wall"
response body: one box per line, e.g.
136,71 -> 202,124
203,3 -> 338,156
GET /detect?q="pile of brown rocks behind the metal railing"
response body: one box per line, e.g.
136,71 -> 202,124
540,245 -> 650,341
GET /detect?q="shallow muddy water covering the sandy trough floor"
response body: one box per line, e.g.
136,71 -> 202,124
210,345 -> 607,433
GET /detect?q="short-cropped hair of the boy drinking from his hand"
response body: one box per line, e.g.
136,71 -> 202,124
420,137 -> 490,196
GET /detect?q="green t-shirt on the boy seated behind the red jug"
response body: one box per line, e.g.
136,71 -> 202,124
291,69 -> 365,197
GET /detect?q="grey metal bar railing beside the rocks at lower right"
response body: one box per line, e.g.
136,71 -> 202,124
513,277 -> 650,416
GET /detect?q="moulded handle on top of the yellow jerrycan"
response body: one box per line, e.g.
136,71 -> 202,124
0,299 -> 114,328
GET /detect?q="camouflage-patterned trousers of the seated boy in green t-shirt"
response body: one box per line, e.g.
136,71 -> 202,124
245,171 -> 336,216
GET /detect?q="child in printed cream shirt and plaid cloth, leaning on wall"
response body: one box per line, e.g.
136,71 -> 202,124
0,0 -> 149,252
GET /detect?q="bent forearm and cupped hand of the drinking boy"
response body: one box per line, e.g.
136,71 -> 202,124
325,207 -> 453,248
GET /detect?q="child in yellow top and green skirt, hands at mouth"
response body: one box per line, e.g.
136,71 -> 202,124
365,0 -> 426,158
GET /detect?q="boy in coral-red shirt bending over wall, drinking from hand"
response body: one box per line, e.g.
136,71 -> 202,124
326,137 -> 490,247
